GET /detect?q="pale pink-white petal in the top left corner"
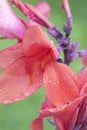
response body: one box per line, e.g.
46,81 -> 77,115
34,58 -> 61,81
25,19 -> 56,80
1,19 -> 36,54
0,0 -> 25,39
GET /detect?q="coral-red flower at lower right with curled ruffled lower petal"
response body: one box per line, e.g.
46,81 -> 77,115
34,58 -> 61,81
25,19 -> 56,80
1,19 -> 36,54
31,62 -> 87,130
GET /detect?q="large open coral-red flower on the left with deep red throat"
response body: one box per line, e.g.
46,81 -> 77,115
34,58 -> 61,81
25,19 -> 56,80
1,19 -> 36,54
0,25 -> 59,103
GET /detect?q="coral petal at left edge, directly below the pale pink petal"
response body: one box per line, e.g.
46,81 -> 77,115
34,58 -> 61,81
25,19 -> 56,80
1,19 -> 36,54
0,43 -> 24,69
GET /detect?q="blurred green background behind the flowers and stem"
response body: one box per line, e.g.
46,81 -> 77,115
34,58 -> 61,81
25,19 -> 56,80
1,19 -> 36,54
0,0 -> 87,130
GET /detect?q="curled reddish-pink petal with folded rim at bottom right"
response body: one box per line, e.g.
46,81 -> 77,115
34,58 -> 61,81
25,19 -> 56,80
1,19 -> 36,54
40,95 -> 85,130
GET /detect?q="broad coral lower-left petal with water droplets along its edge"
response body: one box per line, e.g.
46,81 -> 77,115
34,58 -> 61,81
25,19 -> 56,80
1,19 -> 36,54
0,57 -> 42,103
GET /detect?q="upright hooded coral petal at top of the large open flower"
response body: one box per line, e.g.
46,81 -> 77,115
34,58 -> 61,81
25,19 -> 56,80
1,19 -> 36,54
23,25 -> 59,58
